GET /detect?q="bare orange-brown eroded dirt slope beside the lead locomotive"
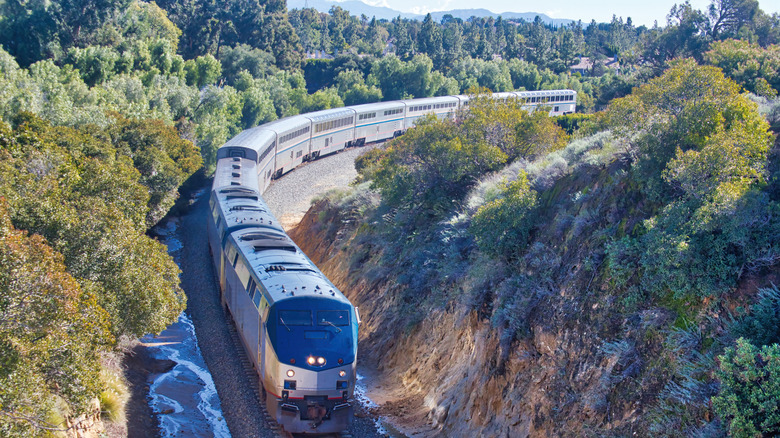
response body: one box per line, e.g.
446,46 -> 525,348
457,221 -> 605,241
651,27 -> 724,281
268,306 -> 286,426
290,200 -> 637,437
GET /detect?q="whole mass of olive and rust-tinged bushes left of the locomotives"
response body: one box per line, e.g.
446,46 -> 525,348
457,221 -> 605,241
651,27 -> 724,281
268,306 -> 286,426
0,113 -> 189,436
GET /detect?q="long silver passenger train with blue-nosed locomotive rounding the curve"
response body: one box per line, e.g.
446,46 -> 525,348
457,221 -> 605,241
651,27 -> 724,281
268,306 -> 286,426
207,90 -> 577,434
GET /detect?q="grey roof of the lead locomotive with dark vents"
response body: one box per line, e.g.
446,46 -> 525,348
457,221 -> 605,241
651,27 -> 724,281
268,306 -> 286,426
225,228 -> 349,305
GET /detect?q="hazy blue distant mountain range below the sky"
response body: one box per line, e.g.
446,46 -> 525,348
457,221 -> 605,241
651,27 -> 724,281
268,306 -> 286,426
287,0 -> 574,26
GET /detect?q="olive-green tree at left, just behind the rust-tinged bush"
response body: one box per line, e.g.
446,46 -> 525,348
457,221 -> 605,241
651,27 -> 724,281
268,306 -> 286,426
0,114 -> 187,337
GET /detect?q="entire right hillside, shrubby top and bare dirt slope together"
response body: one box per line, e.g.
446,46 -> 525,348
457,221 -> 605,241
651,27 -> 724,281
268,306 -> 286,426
296,60 -> 780,436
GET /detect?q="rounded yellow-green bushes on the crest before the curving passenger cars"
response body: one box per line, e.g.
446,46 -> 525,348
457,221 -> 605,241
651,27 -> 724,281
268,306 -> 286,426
356,94 -> 566,218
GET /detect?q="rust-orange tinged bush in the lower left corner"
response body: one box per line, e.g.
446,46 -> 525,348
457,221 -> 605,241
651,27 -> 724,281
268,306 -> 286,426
0,199 -> 113,437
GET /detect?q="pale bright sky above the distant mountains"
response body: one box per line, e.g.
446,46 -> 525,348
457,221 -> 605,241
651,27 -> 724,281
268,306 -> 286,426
362,0 -> 780,27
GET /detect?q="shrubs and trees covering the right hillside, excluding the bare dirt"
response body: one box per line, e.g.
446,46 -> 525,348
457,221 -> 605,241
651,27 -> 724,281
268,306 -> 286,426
353,59 -> 780,436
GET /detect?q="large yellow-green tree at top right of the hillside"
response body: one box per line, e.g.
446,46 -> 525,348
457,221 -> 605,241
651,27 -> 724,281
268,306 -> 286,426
607,60 -> 780,300
